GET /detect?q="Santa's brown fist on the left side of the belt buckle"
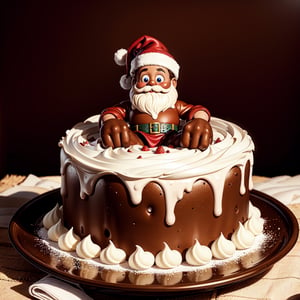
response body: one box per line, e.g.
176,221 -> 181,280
100,119 -> 143,148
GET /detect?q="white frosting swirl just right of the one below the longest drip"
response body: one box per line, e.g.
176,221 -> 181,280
185,240 -> 212,266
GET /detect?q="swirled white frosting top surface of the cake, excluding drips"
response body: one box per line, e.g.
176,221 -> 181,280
60,115 -> 254,179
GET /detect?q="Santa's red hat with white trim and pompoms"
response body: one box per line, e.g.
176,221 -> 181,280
114,35 -> 179,90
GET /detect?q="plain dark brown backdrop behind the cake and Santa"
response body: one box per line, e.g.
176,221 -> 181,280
0,0 -> 300,176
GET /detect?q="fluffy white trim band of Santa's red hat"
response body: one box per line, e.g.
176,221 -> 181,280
130,52 -> 179,79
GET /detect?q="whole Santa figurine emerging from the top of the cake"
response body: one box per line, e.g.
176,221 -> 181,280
99,35 -> 212,150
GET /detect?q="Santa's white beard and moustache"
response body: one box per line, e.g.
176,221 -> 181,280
130,85 -> 178,120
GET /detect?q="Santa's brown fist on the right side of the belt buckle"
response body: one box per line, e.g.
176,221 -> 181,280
181,118 -> 213,150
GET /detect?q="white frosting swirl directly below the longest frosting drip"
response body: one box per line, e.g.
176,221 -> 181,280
155,243 -> 182,269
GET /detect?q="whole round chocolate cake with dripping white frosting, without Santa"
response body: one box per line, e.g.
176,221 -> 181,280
39,116 -> 261,269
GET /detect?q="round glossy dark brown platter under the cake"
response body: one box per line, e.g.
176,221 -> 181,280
9,189 -> 299,297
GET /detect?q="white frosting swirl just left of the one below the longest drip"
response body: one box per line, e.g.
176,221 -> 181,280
128,245 -> 154,270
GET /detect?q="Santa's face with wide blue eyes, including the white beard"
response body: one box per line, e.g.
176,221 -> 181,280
130,65 -> 178,119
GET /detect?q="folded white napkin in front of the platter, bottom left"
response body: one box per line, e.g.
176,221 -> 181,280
29,275 -> 92,300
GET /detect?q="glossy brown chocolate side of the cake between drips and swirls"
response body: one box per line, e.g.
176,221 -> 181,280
62,162 -> 250,255
